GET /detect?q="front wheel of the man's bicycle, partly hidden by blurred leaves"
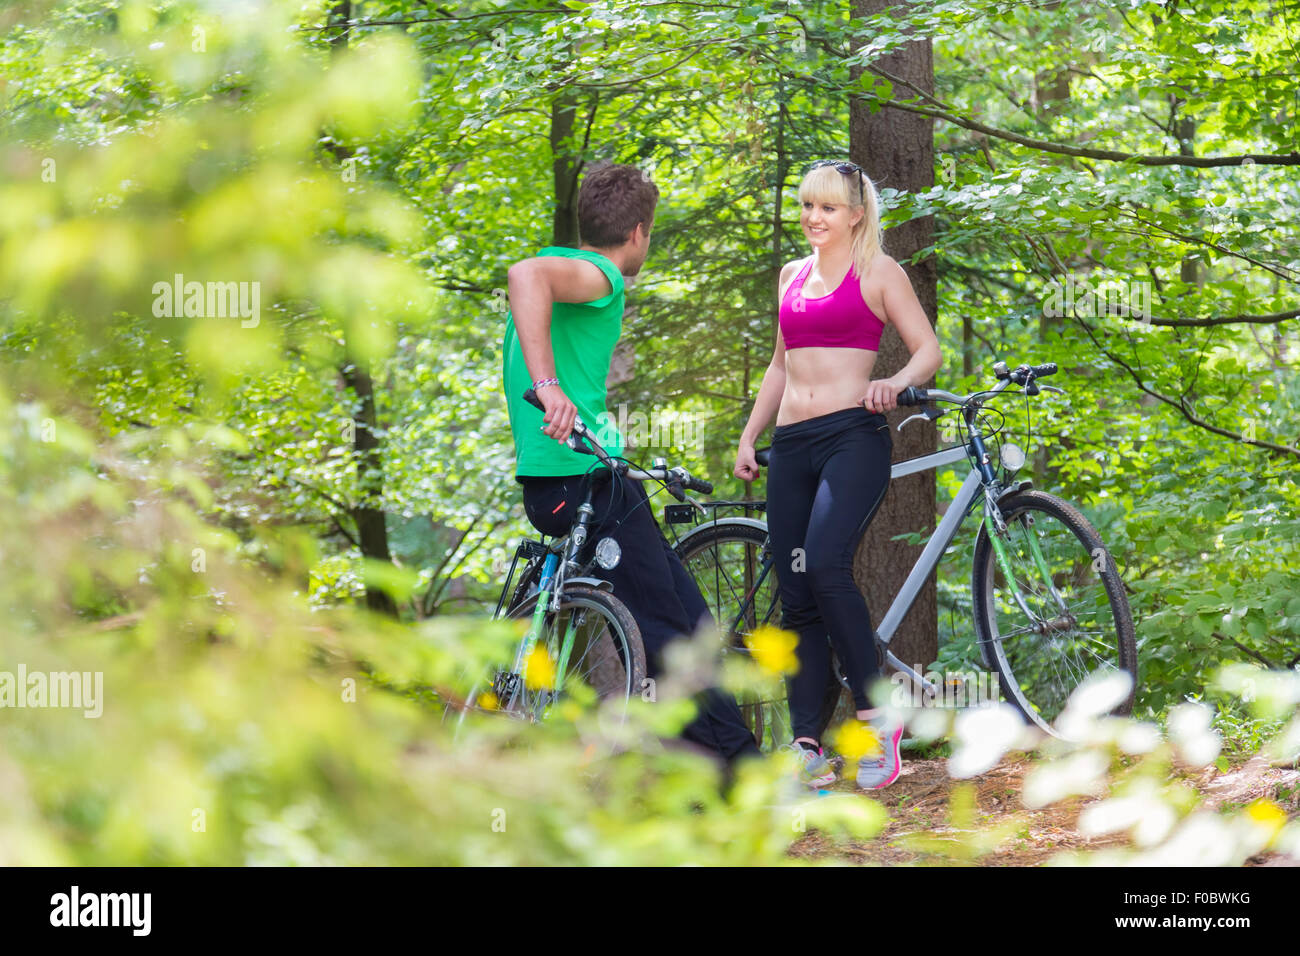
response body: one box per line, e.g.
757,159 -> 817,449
497,584 -> 646,721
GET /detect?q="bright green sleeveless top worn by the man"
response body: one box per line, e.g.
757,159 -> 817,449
502,246 -> 623,480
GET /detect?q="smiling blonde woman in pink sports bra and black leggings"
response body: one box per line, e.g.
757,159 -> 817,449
736,160 -> 941,790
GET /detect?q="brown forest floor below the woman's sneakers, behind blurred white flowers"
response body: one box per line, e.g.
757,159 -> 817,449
790,753 -> 1300,866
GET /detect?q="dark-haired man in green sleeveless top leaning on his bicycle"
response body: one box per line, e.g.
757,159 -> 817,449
502,165 -> 759,761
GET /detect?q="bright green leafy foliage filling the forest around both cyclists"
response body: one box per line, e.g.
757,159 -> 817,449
0,0 -> 1300,864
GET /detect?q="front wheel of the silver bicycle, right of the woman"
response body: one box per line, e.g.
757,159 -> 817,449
971,492 -> 1138,736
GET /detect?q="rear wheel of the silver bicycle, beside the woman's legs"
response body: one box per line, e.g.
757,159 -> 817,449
676,520 -> 842,752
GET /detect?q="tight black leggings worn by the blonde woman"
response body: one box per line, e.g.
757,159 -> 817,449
767,407 -> 893,740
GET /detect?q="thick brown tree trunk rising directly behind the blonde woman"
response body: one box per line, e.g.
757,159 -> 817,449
849,0 -> 939,702
